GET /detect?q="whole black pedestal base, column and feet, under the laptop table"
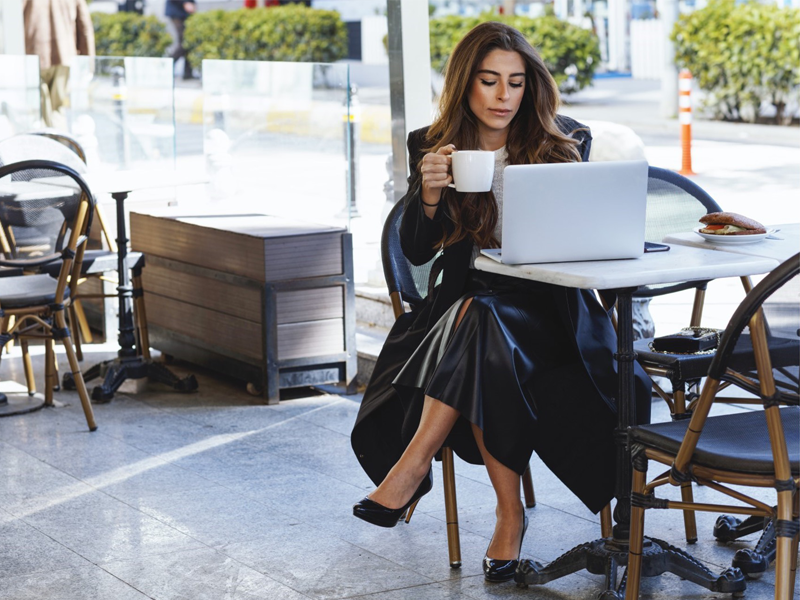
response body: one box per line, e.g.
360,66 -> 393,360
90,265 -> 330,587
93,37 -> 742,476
514,288 -> 746,600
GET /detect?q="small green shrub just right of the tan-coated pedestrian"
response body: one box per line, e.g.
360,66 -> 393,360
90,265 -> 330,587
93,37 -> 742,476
92,12 -> 172,56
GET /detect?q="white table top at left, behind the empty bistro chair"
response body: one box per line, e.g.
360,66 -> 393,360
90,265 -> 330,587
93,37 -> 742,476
34,169 -> 208,194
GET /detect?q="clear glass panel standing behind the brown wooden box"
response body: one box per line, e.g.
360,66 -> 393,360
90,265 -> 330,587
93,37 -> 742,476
203,60 -> 355,227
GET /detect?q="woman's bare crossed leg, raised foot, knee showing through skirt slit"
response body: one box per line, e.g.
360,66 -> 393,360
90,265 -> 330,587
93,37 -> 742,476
369,298 -> 472,508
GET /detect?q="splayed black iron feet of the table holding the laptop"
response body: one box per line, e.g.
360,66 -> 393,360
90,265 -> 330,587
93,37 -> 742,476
514,538 -> 746,600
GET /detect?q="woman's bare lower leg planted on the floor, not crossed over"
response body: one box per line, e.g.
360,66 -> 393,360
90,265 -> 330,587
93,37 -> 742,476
472,424 -> 525,560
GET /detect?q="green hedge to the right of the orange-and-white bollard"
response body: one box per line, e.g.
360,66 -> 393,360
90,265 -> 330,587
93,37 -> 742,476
672,0 -> 800,123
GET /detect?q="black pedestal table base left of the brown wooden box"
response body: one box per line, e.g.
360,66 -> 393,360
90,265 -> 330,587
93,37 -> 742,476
62,192 -> 197,402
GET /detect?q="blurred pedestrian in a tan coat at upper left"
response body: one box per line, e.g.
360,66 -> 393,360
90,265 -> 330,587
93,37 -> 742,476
22,0 -> 94,127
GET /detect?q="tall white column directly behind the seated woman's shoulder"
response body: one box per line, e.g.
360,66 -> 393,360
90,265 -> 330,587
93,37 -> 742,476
386,0 -> 432,200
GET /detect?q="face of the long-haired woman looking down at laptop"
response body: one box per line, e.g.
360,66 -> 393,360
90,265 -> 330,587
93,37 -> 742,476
467,50 -> 525,143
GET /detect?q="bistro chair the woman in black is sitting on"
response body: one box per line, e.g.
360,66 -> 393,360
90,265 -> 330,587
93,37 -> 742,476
381,201 -> 564,568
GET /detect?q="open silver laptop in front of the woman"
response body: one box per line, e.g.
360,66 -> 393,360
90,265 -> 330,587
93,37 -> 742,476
481,160 -> 647,265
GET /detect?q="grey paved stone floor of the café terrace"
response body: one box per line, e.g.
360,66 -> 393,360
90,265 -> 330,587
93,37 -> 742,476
0,347 -> 792,600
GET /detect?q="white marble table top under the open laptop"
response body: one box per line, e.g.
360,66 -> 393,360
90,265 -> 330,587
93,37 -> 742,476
475,244 -> 779,290
